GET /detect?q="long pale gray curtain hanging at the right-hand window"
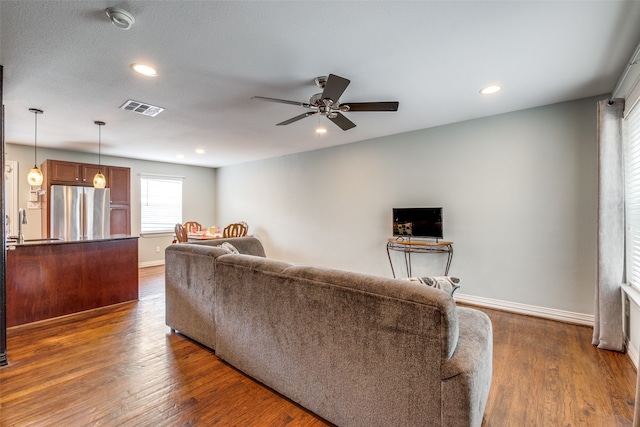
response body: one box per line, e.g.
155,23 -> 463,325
592,99 -> 624,351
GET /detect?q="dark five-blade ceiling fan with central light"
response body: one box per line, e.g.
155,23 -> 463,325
251,74 -> 398,130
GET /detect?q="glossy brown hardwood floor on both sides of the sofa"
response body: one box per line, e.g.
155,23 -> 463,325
0,267 -> 636,427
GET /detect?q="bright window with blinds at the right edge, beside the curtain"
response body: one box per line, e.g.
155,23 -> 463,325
622,104 -> 640,286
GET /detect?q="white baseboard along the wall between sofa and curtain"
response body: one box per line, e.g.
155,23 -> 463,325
454,293 -> 594,326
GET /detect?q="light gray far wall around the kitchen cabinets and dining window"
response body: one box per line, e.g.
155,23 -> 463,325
6,144 -> 215,265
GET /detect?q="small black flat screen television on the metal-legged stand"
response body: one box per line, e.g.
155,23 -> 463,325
393,208 -> 443,239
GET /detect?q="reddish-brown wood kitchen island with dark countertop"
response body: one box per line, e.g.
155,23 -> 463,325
6,235 -> 138,327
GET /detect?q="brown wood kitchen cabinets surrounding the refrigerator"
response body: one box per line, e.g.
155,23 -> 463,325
40,160 -> 131,237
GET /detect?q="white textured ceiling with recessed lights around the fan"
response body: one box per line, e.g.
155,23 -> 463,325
0,0 -> 640,167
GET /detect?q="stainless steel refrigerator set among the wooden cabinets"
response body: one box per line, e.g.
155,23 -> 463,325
49,185 -> 111,241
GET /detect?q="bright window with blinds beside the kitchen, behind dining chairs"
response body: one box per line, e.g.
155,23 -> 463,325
140,175 -> 182,234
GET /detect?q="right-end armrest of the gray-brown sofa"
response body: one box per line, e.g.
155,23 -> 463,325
442,307 -> 493,427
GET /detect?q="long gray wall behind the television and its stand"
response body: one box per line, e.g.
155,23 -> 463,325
216,97 -> 601,314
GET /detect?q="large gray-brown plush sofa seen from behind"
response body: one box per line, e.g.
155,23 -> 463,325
165,237 -> 492,427
